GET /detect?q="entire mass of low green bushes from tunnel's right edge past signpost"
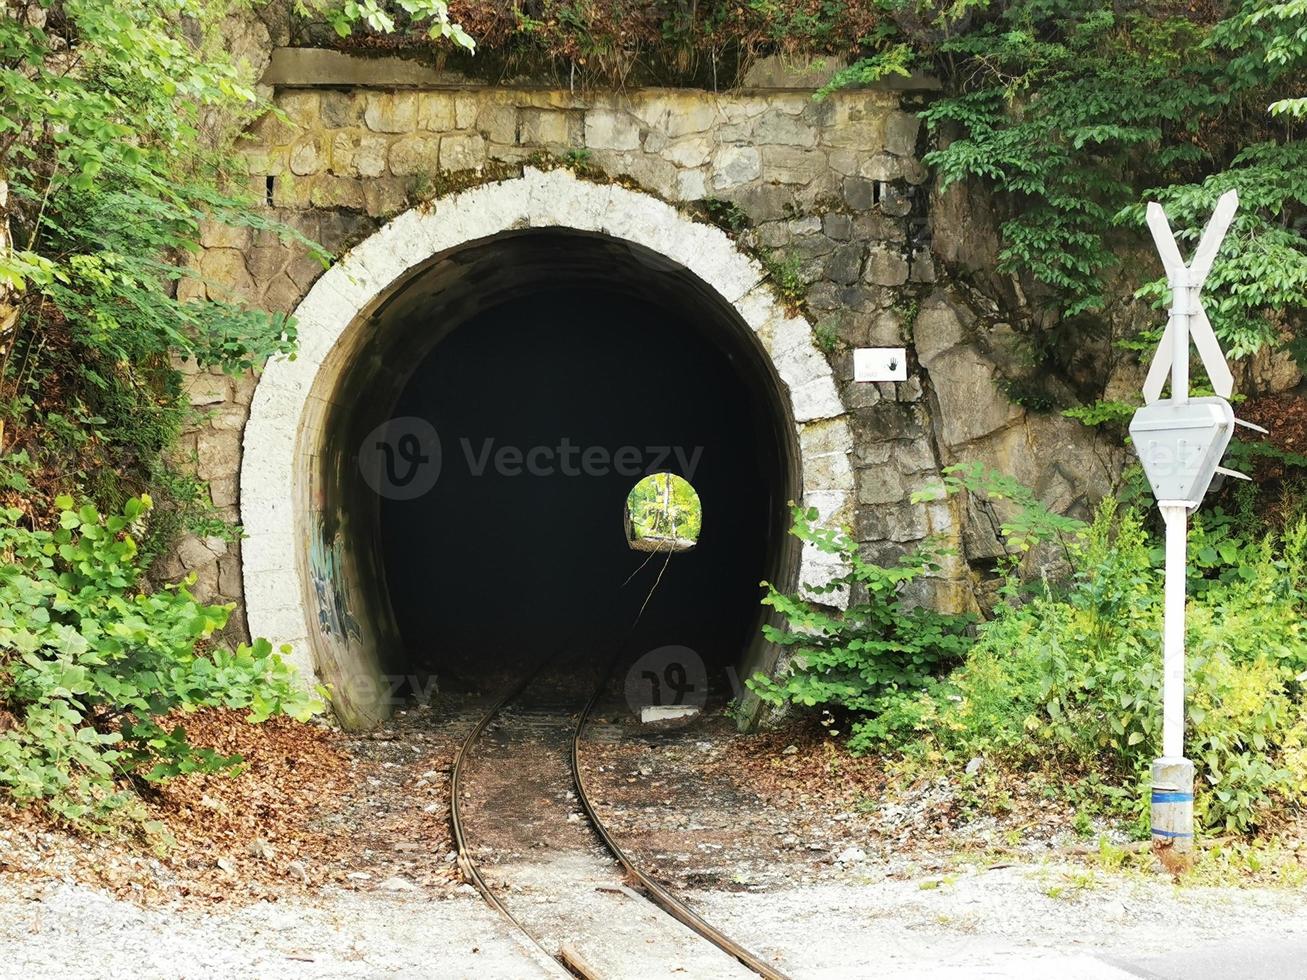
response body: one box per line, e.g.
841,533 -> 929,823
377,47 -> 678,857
749,464 -> 1307,832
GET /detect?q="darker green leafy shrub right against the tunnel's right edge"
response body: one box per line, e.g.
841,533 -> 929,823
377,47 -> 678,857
748,507 -> 970,747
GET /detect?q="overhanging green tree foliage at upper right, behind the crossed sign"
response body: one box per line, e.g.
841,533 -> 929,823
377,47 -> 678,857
822,0 -> 1307,357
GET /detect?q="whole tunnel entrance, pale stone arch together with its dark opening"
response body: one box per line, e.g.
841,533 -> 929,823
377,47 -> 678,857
240,167 -> 855,728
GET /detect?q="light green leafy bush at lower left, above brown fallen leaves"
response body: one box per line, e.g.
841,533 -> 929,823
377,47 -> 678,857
0,498 -> 320,823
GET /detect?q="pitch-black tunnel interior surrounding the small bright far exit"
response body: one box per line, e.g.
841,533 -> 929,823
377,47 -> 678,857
380,281 -> 787,679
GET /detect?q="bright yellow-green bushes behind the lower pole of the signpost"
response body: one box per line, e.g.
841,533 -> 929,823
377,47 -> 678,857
877,499 -> 1307,831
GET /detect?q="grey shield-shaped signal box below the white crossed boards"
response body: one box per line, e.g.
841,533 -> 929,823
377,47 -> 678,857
1131,397 -> 1234,507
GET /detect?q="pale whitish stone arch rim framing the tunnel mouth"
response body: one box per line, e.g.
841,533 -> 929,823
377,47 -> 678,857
240,167 -> 855,721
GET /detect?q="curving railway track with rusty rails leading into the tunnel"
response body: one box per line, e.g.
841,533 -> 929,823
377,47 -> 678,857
450,657 -> 786,980
